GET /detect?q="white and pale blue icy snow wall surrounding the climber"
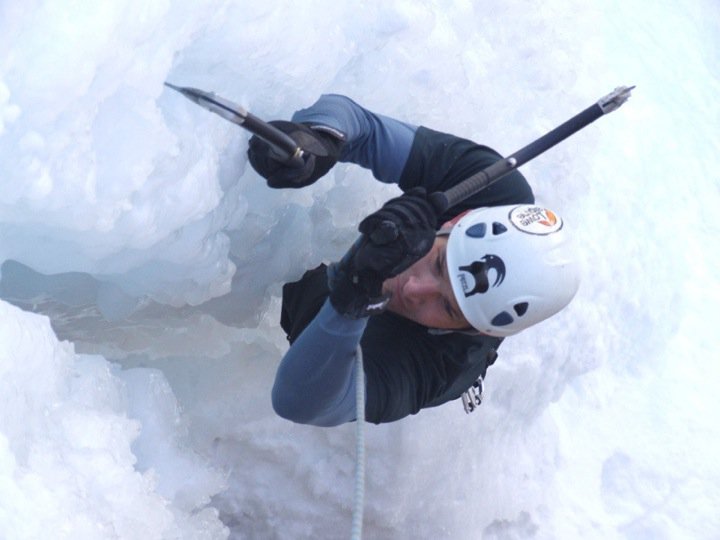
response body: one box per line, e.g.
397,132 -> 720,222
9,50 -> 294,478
0,0 -> 720,539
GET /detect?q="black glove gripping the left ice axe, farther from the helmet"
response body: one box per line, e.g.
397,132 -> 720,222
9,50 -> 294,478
248,120 -> 342,188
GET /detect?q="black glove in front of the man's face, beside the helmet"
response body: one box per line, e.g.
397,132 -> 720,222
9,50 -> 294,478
328,188 -> 438,319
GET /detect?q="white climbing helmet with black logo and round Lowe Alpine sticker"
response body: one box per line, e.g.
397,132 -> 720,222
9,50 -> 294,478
447,204 -> 579,337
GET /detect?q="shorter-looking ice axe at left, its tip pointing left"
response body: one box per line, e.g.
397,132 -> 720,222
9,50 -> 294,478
165,82 -> 303,167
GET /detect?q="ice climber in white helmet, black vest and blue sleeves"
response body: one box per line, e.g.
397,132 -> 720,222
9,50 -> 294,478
248,95 -> 578,426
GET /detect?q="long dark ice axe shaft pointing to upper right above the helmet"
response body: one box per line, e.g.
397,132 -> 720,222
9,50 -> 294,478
431,86 -> 635,213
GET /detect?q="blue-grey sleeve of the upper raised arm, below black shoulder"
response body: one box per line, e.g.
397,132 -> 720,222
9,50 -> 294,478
292,94 -> 417,184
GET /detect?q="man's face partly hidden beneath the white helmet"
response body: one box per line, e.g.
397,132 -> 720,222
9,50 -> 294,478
383,236 -> 470,330
